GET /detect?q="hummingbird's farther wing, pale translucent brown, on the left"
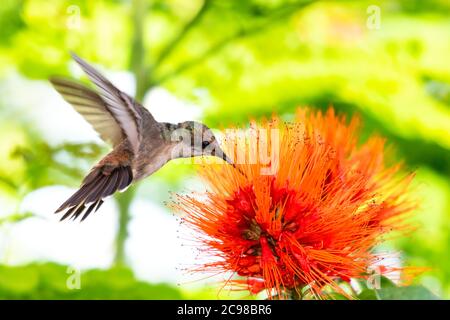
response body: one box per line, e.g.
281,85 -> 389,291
50,77 -> 125,147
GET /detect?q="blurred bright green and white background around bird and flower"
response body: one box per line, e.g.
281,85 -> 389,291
0,0 -> 450,299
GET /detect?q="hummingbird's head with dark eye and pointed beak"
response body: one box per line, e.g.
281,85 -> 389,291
173,121 -> 234,166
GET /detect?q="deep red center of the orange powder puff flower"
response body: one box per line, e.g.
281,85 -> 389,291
227,182 -> 314,279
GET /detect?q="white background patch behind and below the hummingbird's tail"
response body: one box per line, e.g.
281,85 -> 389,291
0,187 -> 117,268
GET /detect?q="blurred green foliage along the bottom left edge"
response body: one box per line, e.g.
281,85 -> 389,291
0,263 -> 183,300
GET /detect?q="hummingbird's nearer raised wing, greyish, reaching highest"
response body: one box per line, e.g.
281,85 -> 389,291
72,53 -> 156,154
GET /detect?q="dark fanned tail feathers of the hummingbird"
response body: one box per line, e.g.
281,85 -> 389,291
55,166 -> 133,221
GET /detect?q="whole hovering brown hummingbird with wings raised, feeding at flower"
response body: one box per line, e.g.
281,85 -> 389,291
50,53 -> 234,221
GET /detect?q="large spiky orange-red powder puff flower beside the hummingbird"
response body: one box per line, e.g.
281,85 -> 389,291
172,109 -> 415,298
